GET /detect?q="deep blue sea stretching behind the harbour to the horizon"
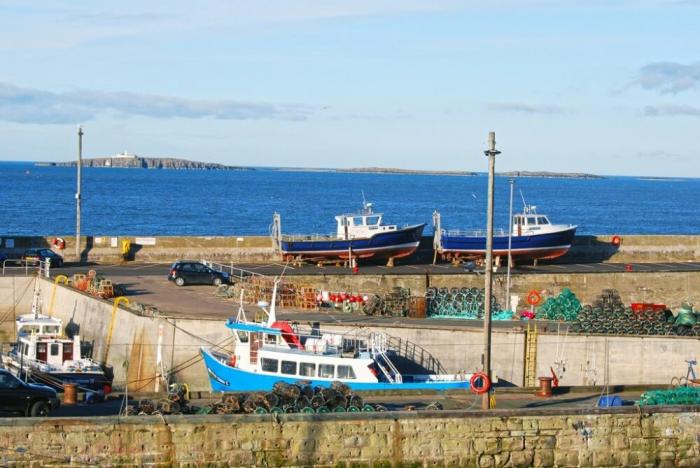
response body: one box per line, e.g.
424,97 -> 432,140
0,162 -> 700,236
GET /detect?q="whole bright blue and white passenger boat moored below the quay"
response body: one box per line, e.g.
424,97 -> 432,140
201,283 -> 470,392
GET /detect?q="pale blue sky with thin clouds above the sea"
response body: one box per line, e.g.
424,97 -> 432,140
0,0 -> 700,177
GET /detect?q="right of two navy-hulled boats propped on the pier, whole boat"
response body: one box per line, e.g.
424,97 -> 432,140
434,204 -> 576,260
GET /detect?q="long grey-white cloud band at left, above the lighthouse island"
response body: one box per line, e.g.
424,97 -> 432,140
0,83 -> 316,124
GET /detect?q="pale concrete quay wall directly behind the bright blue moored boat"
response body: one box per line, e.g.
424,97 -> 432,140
0,278 -> 700,392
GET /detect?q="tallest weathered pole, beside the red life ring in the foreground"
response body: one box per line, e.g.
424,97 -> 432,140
481,132 -> 500,409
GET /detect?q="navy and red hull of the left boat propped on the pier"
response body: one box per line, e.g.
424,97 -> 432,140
280,224 -> 425,259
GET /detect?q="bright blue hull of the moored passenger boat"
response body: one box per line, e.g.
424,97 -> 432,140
201,349 -> 469,392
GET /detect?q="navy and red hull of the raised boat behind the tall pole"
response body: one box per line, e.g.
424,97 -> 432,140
439,226 -> 576,259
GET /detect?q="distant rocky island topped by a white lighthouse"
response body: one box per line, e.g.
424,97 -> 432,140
44,153 -> 254,171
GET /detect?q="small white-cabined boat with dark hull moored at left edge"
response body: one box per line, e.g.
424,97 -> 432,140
2,292 -> 112,394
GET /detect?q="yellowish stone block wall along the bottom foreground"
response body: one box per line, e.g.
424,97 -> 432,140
0,407 -> 700,467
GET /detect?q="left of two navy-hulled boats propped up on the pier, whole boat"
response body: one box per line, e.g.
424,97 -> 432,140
271,197 -> 425,261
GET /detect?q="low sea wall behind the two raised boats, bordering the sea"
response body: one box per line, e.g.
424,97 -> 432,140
0,235 -> 700,263
